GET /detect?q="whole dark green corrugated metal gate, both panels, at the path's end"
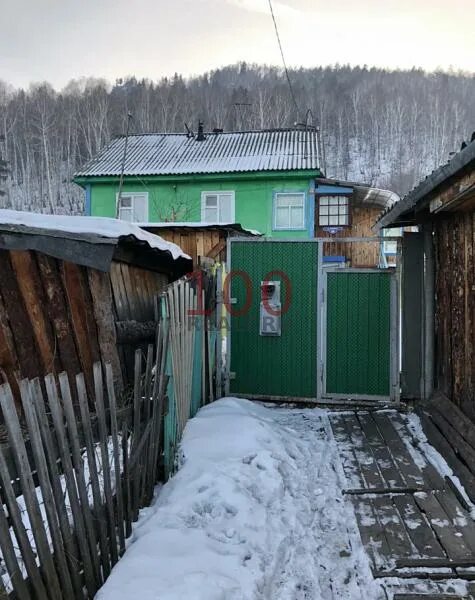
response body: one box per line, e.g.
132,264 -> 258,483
229,238 -> 399,402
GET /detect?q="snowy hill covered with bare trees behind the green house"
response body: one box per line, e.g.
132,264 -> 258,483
0,64 -> 475,212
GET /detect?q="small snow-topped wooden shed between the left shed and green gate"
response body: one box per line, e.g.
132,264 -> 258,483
140,222 -> 261,267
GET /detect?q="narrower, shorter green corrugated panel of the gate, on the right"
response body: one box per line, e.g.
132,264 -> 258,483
326,272 -> 392,396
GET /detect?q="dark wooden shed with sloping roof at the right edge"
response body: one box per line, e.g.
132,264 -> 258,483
379,134 -> 475,420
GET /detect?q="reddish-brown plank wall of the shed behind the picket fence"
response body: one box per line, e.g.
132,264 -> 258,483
0,250 -> 168,402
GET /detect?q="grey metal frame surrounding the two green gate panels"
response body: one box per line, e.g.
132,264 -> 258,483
223,235 -> 402,407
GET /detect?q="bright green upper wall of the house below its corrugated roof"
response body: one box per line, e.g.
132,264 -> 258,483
82,172 -> 316,238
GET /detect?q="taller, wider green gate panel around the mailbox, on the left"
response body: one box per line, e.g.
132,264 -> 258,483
230,242 -> 317,398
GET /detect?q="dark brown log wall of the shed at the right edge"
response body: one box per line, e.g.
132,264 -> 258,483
434,212 -> 475,420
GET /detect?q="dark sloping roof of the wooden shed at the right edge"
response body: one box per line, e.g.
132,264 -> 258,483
377,135 -> 475,227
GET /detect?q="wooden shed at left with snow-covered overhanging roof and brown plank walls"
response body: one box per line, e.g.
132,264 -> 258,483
0,210 -> 192,404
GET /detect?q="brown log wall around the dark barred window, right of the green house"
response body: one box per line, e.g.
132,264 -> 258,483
315,205 -> 381,267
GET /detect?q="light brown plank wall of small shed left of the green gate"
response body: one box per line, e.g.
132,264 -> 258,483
148,227 -> 228,267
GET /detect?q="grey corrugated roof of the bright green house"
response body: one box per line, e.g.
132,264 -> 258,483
75,129 -> 318,177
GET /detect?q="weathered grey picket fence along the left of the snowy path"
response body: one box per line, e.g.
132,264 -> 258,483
0,270 -> 221,600
